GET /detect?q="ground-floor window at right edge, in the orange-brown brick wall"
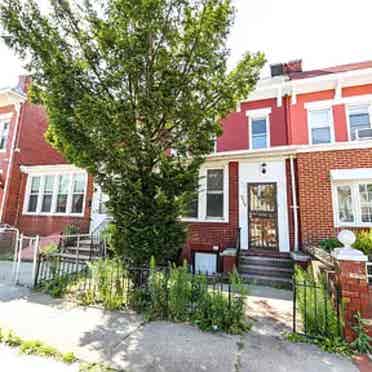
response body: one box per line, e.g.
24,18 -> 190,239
334,181 -> 372,227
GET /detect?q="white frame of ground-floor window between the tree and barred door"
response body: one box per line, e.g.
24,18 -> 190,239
181,162 -> 230,223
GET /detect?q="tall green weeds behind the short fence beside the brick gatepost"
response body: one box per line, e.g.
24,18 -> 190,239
295,266 -> 342,340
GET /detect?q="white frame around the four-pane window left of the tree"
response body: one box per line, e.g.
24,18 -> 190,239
23,170 -> 88,217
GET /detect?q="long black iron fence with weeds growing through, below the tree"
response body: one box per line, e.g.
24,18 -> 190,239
35,255 -> 244,313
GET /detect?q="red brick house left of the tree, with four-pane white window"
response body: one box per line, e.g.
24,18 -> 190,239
0,77 -> 93,236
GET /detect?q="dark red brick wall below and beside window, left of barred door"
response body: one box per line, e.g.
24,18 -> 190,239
183,162 -> 239,259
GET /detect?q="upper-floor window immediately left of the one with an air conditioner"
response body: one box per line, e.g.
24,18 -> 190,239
309,109 -> 332,145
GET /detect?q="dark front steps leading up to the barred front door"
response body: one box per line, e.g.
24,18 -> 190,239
239,255 -> 294,289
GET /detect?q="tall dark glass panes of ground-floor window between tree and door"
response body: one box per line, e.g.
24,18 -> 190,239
207,169 -> 224,218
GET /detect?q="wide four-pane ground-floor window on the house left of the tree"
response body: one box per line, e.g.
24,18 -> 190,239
26,173 -> 86,215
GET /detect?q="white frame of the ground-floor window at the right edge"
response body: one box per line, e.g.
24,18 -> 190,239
332,179 -> 372,227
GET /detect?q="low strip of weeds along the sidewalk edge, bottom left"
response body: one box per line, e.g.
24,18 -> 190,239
0,328 -> 77,364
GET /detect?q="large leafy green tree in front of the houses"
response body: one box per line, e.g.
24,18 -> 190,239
0,0 -> 264,264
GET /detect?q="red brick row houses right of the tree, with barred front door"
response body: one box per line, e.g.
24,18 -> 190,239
184,61 -> 372,277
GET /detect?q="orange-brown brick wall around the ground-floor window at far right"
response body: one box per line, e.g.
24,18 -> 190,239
297,149 -> 372,245
